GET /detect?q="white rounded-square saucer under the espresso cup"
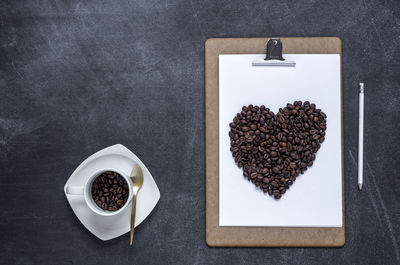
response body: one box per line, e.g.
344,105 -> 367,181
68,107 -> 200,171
64,144 -> 160,240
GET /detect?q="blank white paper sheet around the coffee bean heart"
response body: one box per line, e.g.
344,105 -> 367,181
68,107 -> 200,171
219,54 -> 342,227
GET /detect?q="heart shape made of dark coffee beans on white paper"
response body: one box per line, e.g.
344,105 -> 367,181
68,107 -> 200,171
229,101 -> 326,199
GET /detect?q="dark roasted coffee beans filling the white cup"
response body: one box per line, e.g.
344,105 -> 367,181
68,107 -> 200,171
92,171 -> 129,211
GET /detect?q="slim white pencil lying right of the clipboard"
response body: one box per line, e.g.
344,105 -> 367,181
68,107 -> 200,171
358,83 -> 364,190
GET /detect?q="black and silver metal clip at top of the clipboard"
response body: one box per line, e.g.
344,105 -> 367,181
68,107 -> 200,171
252,38 -> 296,67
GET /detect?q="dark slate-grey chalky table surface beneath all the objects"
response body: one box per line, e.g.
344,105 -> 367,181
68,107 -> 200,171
0,0 -> 400,265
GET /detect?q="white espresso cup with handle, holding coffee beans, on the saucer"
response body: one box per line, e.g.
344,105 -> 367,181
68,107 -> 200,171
66,168 -> 133,216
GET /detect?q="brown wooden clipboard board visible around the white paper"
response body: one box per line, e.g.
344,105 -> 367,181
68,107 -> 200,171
205,37 -> 345,247
